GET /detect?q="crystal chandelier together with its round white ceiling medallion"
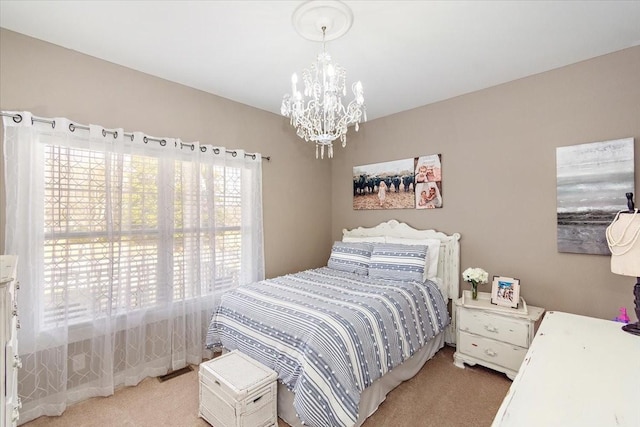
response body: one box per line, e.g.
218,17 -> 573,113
280,2 -> 367,159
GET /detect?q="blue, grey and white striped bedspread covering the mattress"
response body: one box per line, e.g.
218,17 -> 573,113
207,267 -> 450,427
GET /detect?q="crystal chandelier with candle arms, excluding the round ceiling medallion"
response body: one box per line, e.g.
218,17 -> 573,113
280,26 -> 367,159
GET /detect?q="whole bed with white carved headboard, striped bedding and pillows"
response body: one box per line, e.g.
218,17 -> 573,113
207,220 -> 460,427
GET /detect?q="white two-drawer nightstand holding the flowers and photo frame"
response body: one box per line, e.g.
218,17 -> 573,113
453,291 -> 544,380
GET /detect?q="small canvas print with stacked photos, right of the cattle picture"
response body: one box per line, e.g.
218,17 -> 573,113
414,154 -> 442,209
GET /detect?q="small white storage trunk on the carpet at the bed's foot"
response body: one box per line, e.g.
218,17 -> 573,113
199,350 -> 278,427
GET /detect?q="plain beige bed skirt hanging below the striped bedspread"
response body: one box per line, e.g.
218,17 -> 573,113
278,332 -> 445,427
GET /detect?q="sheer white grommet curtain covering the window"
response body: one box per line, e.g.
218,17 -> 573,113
3,112 -> 264,421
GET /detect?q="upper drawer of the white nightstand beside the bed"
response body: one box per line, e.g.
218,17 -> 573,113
458,309 -> 530,348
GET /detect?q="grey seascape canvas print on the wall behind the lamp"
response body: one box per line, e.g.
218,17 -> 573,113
556,138 -> 635,255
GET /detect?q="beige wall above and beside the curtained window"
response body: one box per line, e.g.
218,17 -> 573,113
0,29 -> 331,277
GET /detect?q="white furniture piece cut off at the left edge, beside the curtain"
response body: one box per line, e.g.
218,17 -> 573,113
0,255 -> 22,427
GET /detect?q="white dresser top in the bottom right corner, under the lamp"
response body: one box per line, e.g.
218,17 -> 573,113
492,311 -> 640,427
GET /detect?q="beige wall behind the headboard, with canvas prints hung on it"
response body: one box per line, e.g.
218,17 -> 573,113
331,47 -> 640,318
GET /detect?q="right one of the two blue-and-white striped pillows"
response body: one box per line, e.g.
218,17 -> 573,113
369,243 -> 428,283
